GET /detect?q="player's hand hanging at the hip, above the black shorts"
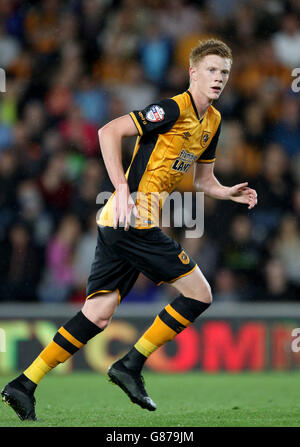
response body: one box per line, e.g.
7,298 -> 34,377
114,183 -> 140,231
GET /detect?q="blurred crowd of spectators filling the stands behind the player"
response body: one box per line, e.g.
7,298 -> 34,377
0,0 -> 300,302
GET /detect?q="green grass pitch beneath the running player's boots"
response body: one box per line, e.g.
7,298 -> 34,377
0,371 -> 300,427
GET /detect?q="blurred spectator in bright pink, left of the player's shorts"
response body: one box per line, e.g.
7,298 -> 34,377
38,215 -> 81,302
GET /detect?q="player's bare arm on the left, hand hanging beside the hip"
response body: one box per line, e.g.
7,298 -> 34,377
98,115 -> 138,231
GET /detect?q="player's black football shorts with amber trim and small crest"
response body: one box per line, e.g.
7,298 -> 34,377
86,226 -> 196,301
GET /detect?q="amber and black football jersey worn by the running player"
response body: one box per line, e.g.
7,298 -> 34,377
98,91 -> 221,229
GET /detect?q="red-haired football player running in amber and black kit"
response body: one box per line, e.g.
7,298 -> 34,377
1,39 -> 257,420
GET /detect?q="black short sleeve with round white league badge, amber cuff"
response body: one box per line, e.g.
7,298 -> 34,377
130,98 -> 180,136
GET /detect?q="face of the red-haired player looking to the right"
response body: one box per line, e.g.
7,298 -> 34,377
190,54 -> 231,101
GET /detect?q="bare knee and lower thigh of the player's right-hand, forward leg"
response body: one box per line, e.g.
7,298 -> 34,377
171,266 -> 212,303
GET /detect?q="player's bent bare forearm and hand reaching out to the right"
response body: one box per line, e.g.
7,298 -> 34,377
194,163 -> 257,209
